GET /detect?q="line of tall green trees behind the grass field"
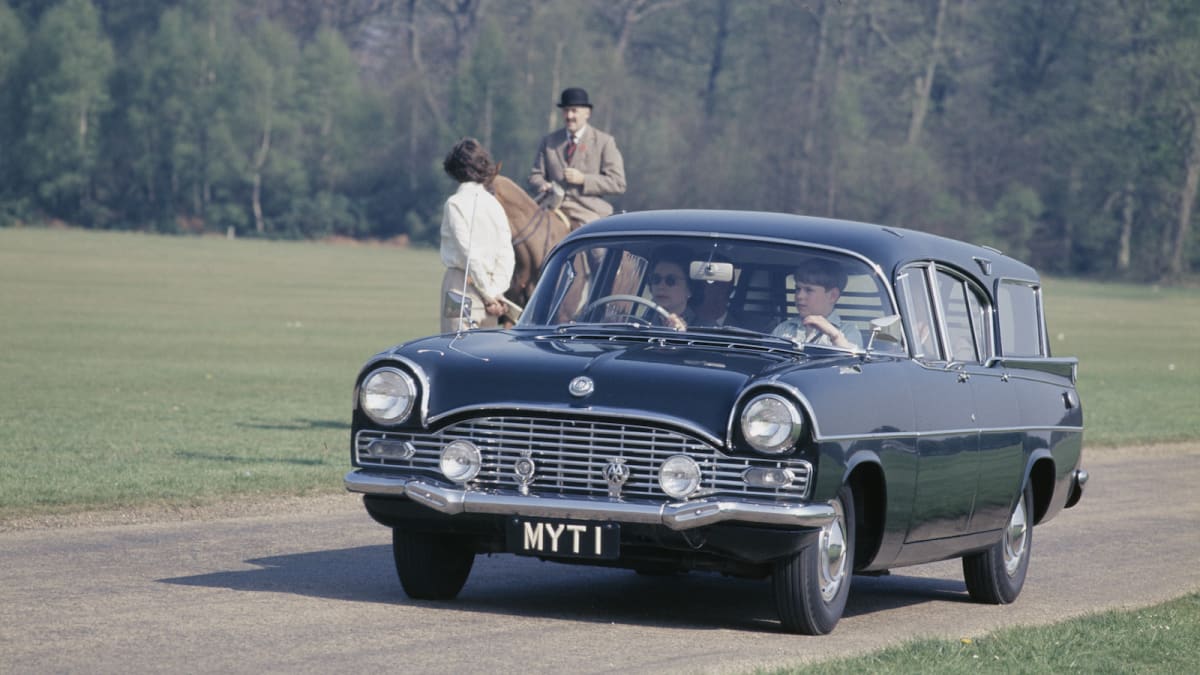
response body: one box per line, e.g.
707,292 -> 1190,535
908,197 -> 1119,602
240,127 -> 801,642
0,0 -> 1200,281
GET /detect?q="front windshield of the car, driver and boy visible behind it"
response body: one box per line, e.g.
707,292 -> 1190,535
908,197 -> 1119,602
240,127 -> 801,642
520,234 -> 900,350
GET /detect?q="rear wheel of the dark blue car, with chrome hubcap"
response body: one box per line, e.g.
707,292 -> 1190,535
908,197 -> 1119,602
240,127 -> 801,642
962,484 -> 1033,604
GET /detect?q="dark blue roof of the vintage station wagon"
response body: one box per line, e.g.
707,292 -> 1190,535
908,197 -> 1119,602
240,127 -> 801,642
564,210 -> 1038,288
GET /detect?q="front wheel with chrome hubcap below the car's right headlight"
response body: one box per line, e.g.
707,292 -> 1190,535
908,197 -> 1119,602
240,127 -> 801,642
772,485 -> 854,635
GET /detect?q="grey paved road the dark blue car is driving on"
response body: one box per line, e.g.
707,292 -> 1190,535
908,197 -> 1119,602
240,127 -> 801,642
0,444 -> 1200,673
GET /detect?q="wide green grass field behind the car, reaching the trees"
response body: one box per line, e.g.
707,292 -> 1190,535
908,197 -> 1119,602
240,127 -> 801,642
0,229 -> 1200,514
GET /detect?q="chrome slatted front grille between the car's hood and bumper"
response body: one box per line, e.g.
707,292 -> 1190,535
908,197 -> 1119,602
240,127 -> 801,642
354,417 -> 811,502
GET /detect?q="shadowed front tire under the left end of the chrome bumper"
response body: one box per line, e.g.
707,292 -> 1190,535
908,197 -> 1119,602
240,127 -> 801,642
391,528 -> 475,601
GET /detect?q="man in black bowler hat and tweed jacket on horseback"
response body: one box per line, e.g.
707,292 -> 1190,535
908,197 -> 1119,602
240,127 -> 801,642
529,86 -> 625,229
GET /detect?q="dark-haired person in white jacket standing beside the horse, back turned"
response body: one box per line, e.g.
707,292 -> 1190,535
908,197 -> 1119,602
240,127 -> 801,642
442,138 -> 514,333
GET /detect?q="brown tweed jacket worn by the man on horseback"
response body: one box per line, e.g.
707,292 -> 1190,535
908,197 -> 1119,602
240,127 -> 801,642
529,125 -> 625,222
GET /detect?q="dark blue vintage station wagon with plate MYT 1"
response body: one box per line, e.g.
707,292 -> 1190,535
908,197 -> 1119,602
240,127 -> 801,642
346,210 -> 1087,634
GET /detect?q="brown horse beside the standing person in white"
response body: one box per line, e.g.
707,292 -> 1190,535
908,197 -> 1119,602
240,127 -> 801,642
492,175 -> 570,307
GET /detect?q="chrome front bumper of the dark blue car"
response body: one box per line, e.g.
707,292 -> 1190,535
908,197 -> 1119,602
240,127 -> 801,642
346,470 -> 835,530
